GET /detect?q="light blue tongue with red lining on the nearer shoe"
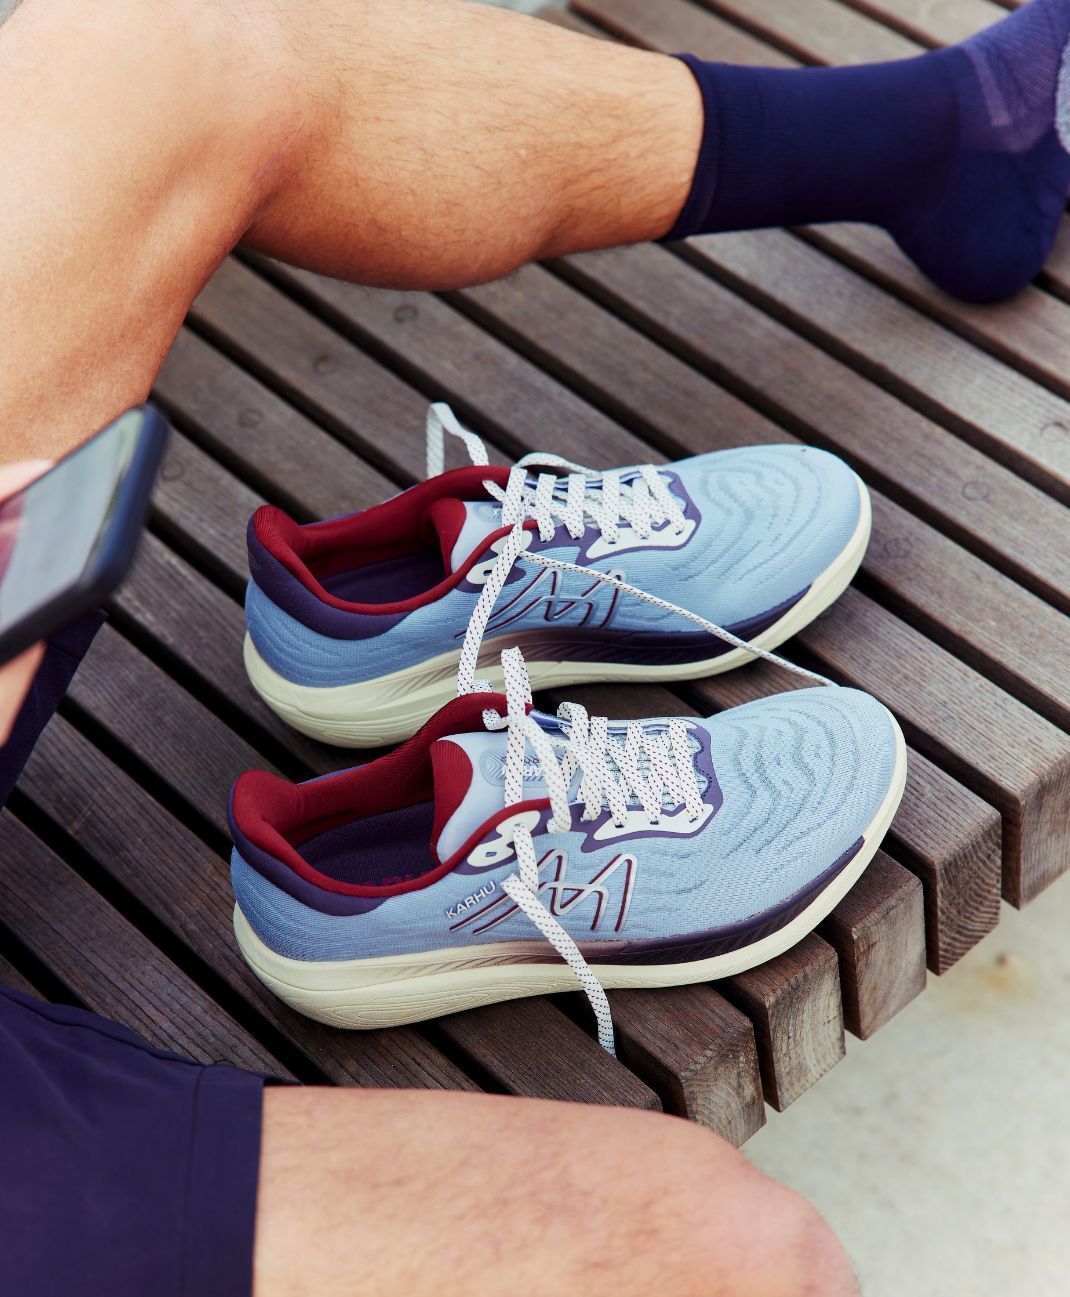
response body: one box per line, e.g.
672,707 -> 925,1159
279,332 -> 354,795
431,733 -> 546,861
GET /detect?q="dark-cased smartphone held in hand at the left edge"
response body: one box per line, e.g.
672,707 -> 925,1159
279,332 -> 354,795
0,406 -> 167,664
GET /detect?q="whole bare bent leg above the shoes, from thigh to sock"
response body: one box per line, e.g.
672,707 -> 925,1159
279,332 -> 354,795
0,0 -> 702,460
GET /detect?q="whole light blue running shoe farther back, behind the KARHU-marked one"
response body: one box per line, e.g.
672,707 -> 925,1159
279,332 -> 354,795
245,406 -> 870,747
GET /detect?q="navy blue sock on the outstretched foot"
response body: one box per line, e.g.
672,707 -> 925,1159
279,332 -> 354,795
667,0 -> 1070,301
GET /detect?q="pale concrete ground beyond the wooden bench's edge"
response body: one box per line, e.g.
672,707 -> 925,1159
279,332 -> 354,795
744,878 -> 1070,1297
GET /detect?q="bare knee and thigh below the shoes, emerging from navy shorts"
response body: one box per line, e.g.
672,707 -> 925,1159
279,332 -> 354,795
254,1089 -> 856,1297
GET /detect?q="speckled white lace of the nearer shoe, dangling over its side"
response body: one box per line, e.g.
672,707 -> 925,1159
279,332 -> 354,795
482,649 -> 704,1054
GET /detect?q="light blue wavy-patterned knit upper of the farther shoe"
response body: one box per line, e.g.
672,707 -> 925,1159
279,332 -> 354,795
245,445 -> 861,686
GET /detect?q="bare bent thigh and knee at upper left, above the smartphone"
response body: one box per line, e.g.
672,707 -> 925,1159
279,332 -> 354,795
0,0 -> 302,459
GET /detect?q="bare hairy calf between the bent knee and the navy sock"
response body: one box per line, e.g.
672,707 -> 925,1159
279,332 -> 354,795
242,0 -> 703,288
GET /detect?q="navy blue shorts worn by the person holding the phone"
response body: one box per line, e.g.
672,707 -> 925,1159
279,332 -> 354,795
0,617 -> 263,1297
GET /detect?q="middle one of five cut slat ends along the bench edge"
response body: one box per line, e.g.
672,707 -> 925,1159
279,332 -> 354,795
818,851 -> 925,1040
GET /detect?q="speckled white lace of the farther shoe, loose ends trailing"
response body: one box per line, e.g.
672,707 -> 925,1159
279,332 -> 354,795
427,403 -> 833,694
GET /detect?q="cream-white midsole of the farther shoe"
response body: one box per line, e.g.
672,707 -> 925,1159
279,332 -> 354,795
245,477 -> 873,747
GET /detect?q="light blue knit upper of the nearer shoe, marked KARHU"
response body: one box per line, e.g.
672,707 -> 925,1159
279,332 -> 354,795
232,687 -> 896,960
